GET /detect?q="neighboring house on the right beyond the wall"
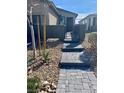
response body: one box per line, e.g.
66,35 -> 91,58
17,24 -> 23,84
79,13 -> 97,32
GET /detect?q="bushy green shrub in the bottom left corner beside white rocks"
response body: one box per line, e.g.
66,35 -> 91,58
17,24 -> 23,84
27,76 -> 40,93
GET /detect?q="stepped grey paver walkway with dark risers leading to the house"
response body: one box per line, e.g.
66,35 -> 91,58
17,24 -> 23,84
56,32 -> 97,93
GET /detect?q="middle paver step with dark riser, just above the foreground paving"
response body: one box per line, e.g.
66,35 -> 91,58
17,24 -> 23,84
59,52 -> 90,68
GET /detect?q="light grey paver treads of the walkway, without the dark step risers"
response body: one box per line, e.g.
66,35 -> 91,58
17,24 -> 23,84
56,34 -> 97,93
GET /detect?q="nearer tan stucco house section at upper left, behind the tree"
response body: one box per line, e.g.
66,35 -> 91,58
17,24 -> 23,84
27,0 -> 58,25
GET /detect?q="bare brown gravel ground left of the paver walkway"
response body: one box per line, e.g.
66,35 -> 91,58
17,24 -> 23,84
27,41 -> 62,84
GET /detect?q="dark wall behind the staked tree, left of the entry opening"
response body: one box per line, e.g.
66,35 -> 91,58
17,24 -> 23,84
27,24 -> 66,43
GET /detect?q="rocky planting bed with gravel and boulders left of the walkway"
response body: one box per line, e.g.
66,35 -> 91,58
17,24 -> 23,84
27,41 -> 62,93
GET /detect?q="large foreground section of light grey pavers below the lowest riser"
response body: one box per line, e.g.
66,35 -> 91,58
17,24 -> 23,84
56,69 -> 97,93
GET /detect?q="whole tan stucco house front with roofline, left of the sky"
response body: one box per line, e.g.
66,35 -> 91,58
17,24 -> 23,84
27,0 -> 77,25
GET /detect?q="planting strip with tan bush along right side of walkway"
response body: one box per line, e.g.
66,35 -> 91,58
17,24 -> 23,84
82,32 -> 97,73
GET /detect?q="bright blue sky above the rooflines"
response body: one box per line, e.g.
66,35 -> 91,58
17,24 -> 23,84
52,0 -> 97,23
